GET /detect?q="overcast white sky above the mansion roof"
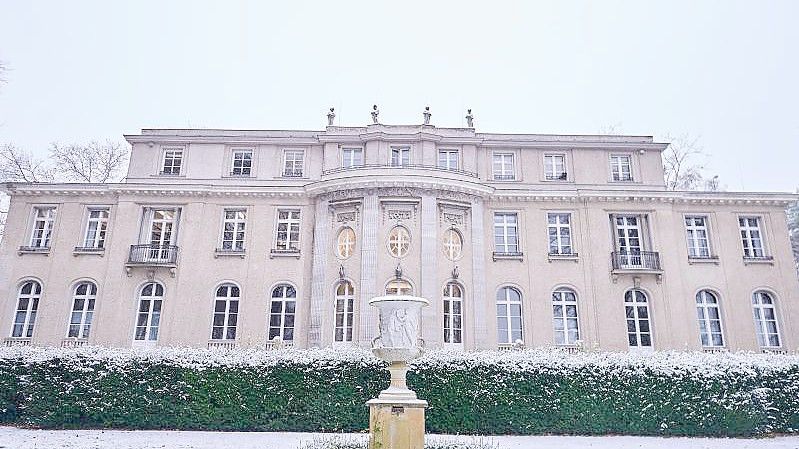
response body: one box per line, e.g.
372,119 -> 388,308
0,0 -> 799,191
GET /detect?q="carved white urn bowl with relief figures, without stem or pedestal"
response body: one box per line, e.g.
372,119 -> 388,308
369,295 -> 430,363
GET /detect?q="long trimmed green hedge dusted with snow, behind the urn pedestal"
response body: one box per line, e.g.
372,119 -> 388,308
0,347 -> 799,435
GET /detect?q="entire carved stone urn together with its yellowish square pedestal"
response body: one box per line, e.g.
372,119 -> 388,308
366,296 -> 429,449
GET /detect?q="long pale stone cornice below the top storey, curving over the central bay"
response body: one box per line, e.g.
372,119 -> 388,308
2,181 -> 799,207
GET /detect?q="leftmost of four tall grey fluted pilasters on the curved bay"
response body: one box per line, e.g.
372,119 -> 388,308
308,199 -> 330,348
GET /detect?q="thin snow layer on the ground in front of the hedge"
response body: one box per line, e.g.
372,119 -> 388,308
0,427 -> 799,449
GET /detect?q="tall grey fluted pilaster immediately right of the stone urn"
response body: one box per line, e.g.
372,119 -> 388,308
419,192 -> 442,348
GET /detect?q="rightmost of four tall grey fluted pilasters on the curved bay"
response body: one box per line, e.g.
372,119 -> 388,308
466,198 -> 494,349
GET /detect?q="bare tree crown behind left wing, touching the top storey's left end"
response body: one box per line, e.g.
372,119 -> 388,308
50,141 -> 128,183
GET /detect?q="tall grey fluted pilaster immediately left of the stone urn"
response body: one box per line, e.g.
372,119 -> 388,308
356,192 -> 383,347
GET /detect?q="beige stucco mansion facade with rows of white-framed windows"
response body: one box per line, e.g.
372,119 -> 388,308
0,124 -> 799,351
